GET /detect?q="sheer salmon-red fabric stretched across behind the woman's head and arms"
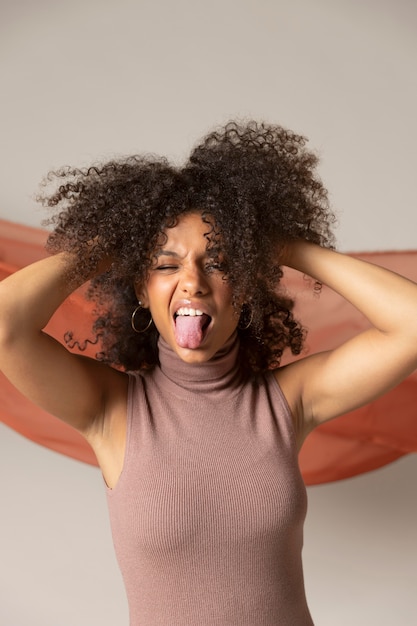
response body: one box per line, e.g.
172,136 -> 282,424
0,220 -> 417,485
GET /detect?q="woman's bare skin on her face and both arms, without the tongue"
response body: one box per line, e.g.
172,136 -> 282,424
0,213 -> 417,487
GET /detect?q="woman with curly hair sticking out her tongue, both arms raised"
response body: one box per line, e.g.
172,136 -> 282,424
0,123 -> 417,626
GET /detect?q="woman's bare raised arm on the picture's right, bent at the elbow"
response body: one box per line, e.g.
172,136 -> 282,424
277,242 -> 417,428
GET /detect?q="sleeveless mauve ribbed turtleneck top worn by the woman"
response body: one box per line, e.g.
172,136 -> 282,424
107,336 -> 313,626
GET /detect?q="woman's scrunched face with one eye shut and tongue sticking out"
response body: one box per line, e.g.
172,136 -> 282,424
137,213 -> 238,363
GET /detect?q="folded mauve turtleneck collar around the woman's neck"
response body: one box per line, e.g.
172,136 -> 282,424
158,333 -> 242,392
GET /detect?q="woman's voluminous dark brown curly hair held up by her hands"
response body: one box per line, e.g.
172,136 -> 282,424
39,122 -> 335,374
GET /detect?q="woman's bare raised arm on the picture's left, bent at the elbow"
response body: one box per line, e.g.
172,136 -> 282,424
0,253 -> 122,435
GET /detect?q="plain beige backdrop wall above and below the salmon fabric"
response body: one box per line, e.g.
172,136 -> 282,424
0,0 -> 417,626
